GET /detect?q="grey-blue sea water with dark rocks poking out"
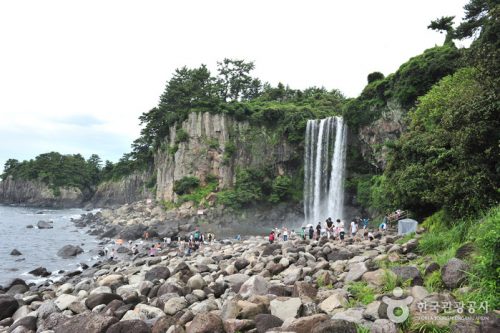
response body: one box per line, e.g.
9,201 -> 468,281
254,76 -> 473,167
0,206 -> 98,285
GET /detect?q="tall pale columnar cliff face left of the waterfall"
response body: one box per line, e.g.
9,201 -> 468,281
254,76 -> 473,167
155,113 -> 298,201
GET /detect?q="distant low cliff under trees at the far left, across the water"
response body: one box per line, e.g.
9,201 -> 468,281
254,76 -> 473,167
0,177 -> 85,208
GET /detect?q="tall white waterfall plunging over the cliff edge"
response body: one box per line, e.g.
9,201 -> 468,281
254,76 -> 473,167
304,117 -> 347,225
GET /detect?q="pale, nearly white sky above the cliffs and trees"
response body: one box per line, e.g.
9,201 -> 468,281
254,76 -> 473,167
0,0 -> 468,171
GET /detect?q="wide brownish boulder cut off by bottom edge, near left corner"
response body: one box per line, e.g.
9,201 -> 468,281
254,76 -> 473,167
54,312 -> 118,333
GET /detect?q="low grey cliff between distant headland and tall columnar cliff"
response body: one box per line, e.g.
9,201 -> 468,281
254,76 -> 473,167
90,171 -> 154,207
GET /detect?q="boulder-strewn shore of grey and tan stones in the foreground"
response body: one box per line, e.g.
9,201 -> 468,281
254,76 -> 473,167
0,215 -> 498,333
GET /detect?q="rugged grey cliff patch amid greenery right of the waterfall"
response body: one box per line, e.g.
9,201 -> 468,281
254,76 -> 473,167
358,102 -> 407,170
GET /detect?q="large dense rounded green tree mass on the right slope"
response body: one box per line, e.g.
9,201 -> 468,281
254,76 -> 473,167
385,68 -> 500,217
